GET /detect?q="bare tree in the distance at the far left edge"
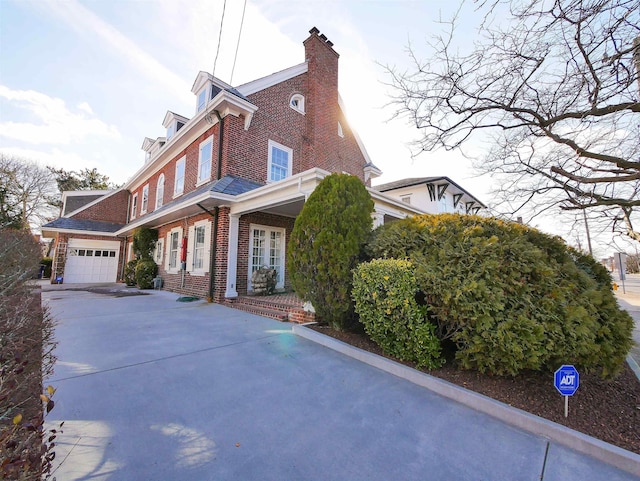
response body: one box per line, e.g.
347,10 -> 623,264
0,153 -> 57,228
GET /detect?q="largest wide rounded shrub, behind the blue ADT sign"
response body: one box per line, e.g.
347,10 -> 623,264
369,214 -> 633,376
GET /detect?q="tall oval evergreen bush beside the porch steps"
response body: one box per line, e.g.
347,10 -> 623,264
287,174 -> 373,330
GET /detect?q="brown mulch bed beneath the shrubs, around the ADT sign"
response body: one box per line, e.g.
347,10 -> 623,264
308,326 -> 640,454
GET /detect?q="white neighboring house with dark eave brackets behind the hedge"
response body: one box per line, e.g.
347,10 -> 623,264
373,177 -> 486,214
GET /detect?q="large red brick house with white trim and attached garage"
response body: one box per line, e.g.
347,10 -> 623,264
43,28 -> 422,302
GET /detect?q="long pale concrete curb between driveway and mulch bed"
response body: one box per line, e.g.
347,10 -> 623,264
292,324 -> 640,476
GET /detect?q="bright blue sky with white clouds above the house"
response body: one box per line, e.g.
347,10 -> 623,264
0,0 -> 632,255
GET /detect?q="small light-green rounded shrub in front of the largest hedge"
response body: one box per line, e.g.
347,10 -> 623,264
353,259 -> 443,369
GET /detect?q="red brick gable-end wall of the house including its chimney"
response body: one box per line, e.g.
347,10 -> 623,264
222,29 -> 366,183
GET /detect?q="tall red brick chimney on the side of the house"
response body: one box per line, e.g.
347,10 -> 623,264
302,27 -> 341,172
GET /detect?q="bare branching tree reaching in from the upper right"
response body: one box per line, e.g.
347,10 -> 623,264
387,0 -> 640,241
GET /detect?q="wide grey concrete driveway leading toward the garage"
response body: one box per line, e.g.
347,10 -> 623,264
43,286 -> 638,481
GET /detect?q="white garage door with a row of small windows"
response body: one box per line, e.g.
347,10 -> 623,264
64,239 -> 120,284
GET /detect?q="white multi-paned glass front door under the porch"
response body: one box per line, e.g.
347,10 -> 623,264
248,225 -> 285,290
